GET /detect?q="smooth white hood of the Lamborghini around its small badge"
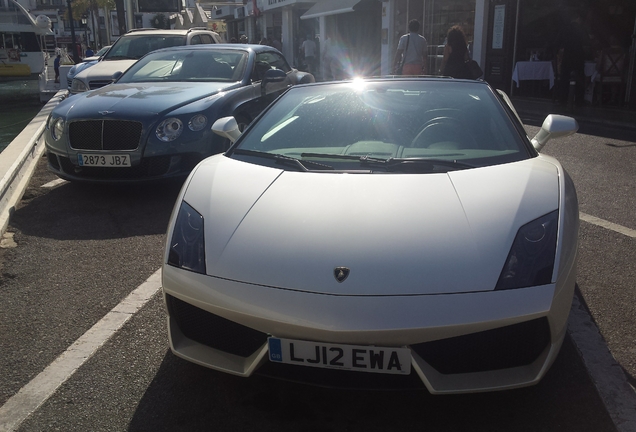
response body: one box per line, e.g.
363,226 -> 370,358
184,155 -> 560,295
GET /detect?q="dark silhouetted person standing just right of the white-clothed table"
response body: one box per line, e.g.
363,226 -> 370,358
555,12 -> 590,105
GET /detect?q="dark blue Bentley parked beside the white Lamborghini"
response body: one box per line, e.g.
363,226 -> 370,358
46,44 -> 315,182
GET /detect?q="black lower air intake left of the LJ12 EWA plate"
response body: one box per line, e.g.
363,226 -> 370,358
166,295 -> 267,357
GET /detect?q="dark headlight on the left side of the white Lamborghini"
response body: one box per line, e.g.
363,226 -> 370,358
168,201 -> 205,274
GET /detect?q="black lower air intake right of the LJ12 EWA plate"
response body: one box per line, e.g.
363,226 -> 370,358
411,318 -> 550,374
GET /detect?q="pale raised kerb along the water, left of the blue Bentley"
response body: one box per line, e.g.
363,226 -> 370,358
0,90 -> 67,235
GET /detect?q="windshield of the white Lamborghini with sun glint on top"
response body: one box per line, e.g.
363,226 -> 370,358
229,79 -> 536,172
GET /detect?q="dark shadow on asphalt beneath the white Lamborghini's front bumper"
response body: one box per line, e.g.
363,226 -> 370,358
129,337 -> 615,432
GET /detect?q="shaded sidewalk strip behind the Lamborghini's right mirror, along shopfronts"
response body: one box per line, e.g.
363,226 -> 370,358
510,96 -> 636,129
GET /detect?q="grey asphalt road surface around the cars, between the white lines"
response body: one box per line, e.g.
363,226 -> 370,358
0,120 -> 636,432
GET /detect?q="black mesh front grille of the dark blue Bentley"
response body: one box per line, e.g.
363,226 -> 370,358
69,120 -> 142,151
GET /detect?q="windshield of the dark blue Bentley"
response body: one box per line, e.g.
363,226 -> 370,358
117,49 -> 247,83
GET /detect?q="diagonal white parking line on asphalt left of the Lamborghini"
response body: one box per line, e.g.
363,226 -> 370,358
0,269 -> 161,431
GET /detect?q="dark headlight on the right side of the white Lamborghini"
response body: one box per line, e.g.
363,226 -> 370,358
495,210 -> 559,290
